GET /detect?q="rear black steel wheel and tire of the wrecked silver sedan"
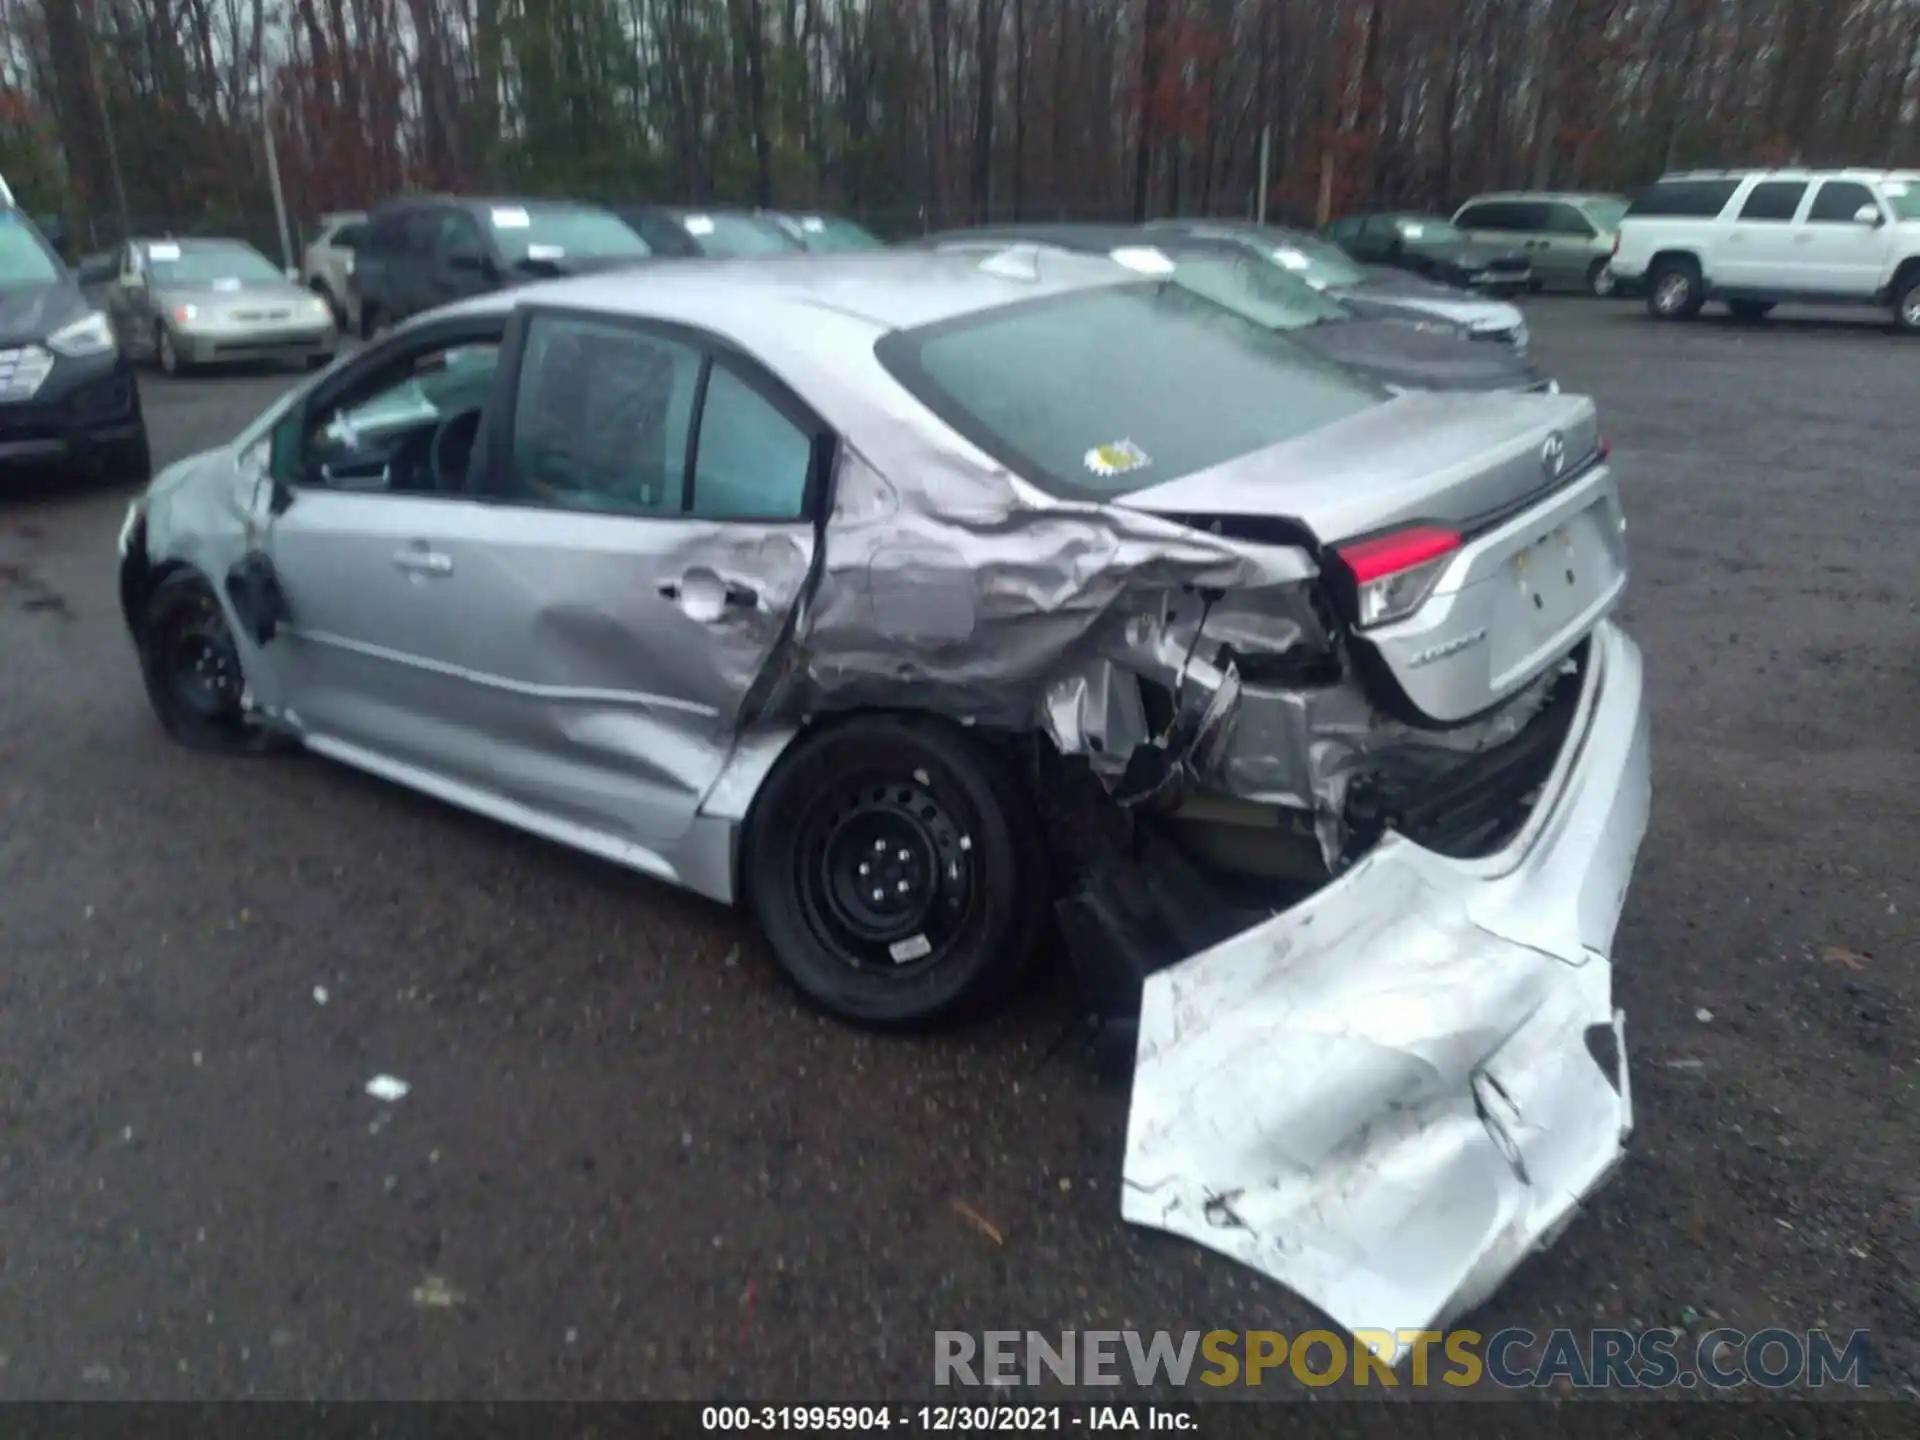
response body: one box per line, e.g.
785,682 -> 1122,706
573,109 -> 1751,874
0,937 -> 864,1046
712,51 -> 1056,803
741,714 -> 1052,1029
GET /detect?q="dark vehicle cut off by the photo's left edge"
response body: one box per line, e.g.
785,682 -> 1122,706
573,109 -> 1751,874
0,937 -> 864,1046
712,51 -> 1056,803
0,205 -> 148,482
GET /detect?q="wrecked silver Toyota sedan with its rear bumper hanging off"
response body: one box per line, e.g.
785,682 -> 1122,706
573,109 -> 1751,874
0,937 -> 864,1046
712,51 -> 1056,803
121,246 -> 1647,1332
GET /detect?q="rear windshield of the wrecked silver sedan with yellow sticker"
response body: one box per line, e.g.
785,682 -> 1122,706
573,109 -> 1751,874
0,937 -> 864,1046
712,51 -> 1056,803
876,282 -> 1386,499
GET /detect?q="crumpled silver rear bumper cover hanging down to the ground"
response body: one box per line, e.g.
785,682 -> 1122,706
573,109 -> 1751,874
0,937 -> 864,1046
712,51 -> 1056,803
1121,622 -> 1651,1359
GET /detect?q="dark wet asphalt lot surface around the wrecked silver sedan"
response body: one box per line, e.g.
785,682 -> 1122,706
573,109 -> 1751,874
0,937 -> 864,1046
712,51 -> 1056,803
0,300 -> 1920,1400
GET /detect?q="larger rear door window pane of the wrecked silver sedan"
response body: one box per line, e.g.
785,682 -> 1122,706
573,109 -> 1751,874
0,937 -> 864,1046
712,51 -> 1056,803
511,315 -> 702,515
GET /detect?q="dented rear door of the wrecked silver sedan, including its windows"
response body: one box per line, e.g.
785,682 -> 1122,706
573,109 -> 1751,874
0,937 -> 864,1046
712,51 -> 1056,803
435,299 -> 831,852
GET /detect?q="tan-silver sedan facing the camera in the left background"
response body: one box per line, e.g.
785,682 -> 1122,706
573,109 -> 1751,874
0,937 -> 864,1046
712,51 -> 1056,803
100,240 -> 340,374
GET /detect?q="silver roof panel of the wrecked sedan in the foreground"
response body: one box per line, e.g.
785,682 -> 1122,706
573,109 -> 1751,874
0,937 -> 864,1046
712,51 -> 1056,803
440,244 -> 1140,346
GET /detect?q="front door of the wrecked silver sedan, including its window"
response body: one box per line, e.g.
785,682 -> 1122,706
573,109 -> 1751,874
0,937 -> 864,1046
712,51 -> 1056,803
267,317 -> 518,789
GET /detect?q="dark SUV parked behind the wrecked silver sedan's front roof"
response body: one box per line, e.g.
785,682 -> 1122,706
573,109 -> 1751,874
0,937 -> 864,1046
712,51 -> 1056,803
353,196 -> 653,338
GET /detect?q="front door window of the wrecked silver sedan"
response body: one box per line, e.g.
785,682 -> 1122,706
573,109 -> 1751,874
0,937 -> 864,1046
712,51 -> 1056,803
291,340 -> 499,493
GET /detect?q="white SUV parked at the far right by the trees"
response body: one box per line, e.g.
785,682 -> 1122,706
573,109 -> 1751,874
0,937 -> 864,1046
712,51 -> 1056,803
1613,169 -> 1920,334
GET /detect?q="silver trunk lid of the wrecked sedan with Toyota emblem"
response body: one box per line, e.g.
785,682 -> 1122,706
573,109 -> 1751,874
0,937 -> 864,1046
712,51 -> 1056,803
1116,394 -> 1628,726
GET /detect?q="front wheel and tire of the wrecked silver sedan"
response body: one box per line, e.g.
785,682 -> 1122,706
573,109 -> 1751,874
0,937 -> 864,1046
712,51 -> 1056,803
134,570 -> 278,755
